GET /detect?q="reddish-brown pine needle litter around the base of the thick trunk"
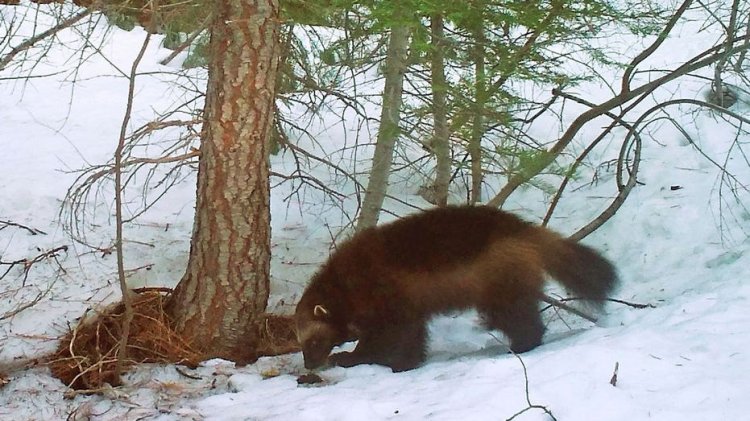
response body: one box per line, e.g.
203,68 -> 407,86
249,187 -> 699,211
49,288 -> 299,391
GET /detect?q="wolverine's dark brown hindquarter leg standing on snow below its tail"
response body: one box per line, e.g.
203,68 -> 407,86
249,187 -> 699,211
478,274 -> 544,353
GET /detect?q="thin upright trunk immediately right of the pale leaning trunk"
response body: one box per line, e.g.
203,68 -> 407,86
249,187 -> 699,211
430,14 -> 451,206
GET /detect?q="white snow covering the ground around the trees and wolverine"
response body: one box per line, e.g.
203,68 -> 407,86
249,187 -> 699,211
0,1 -> 750,421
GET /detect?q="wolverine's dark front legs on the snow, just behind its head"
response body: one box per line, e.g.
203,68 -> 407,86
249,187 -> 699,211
330,320 -> 427,371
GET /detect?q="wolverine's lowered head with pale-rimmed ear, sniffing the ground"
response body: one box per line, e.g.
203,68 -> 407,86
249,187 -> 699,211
295,303 -> 346,369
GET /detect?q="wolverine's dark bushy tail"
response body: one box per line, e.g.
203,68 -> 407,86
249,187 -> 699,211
544,238 -> 618,306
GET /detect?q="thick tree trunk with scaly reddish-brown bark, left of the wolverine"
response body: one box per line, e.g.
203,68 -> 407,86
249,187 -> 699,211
168,0 -> 280,362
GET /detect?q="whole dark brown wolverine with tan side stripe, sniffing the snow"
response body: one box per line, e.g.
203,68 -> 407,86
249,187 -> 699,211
295,206 -> 617,371
